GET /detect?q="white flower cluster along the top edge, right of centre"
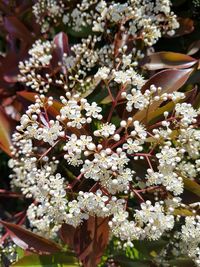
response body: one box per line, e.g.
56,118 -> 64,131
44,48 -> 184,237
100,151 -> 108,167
59,0 -> 179,46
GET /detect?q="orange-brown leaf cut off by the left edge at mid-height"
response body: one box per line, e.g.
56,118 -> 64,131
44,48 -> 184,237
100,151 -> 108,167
0,108 -> 12,156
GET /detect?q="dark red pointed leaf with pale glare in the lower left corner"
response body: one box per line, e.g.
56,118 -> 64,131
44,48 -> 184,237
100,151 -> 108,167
0,221 -> 61,254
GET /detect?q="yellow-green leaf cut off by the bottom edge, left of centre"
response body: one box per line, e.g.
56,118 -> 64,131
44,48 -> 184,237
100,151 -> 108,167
11,252 -> 79,267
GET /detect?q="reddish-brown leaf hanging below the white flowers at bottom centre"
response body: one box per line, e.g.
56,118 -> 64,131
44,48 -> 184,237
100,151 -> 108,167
61,217 -> 109,267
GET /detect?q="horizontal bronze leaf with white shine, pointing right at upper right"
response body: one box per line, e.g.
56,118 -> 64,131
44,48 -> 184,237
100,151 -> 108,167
145,52 -> 197,70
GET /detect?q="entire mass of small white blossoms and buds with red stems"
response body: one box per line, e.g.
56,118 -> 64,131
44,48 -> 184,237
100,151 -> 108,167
1,0 -> 200,266
